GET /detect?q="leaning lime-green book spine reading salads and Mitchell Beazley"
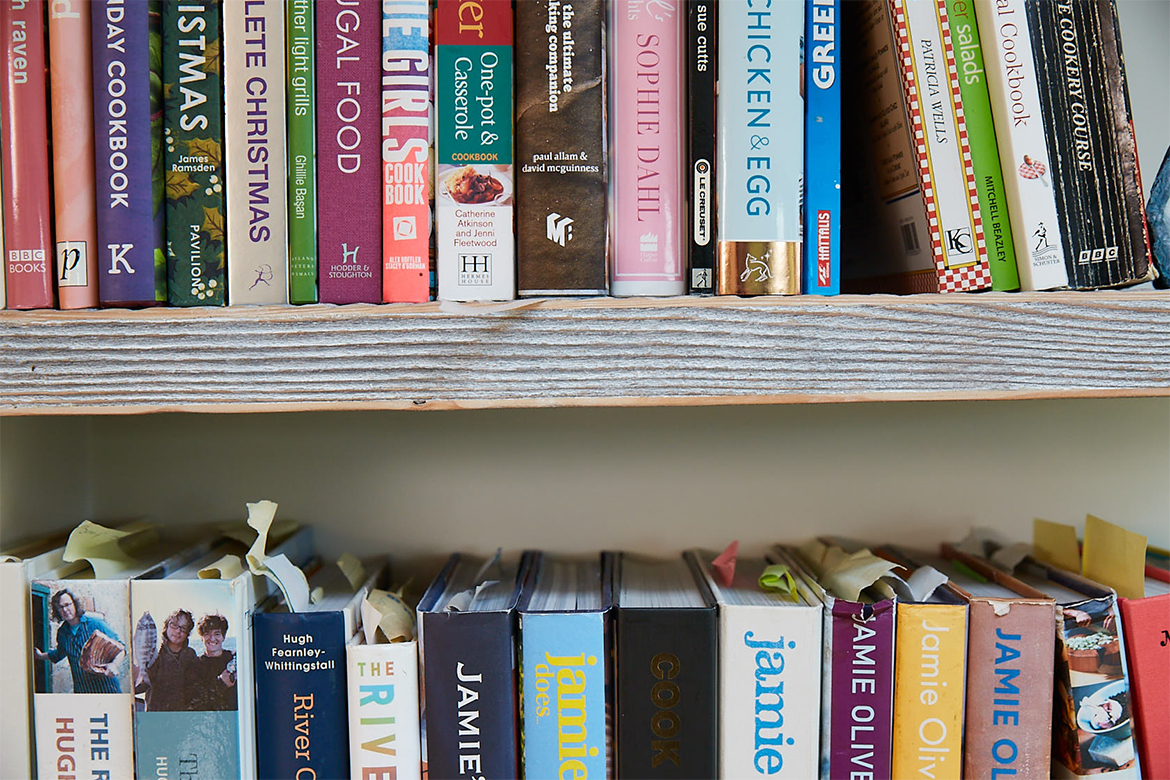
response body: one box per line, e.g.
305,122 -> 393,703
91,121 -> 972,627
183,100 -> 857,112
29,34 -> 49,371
945,0 -> 1020,290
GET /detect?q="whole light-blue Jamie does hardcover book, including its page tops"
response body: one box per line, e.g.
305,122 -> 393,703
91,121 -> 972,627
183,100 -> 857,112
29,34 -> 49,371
517,553 -> 613,778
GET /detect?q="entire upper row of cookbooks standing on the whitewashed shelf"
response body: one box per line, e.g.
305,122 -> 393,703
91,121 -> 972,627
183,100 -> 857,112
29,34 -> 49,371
0,0 -> 1156,309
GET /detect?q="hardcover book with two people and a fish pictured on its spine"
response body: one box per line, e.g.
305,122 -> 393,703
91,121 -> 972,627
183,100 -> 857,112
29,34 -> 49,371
130,529 -> 312,780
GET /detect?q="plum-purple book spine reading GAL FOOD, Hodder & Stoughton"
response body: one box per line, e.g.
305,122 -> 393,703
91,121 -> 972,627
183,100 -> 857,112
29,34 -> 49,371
316,0 -> 381,303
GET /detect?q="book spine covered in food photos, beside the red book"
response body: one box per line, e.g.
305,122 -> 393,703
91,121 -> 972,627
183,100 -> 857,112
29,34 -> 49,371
1052,594 -> 1141,776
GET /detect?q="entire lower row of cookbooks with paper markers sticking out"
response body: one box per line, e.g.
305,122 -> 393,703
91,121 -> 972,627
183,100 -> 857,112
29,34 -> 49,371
0,502 -> 1170,780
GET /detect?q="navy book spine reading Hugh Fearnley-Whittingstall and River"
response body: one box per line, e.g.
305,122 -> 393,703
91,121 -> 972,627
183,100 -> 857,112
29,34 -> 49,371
253,612 -> 350,780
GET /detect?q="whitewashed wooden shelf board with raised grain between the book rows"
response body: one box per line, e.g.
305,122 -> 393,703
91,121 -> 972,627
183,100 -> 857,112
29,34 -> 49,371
0,291 -> 1170,415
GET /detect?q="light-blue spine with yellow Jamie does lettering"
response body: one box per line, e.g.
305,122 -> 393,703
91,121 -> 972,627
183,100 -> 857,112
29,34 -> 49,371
521,613 -> 610,778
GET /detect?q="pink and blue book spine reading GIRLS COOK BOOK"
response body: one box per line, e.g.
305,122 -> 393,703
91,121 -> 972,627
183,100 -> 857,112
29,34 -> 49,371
381,0 -> 432,303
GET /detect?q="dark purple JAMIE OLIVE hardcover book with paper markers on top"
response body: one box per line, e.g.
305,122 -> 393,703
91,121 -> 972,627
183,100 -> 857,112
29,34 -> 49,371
772,541 -> 896,780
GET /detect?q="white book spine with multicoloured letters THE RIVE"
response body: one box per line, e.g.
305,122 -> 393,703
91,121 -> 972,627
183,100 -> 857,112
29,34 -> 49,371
345,642 -> 423,780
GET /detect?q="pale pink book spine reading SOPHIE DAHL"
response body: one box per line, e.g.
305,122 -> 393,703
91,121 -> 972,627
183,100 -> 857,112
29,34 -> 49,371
611,0 -> 687,296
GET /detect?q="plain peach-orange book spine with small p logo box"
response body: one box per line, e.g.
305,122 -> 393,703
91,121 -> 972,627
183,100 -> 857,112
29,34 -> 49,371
49,0 -> 97,309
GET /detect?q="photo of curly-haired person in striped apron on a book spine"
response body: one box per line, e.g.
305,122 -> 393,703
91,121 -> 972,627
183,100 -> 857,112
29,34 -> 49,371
33,581 -> 129,693
